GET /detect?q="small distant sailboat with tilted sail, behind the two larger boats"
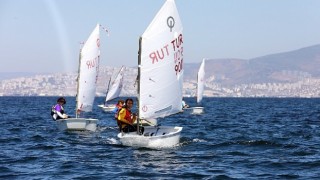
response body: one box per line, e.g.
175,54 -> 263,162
98,66 -> 125,111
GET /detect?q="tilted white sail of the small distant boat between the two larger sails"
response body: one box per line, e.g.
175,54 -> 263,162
106,67 -> 125,101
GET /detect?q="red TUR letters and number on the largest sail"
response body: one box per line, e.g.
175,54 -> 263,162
149,34 -> 183,74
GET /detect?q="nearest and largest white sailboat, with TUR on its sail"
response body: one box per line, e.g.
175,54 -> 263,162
118,0 -> 183,148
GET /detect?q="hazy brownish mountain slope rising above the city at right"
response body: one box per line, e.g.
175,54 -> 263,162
184,45 -> 320,86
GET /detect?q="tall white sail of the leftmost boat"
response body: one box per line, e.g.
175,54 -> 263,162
77,24 -> 100,112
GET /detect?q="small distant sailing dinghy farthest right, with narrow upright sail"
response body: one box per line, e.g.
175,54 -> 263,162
183,59 -> 205,114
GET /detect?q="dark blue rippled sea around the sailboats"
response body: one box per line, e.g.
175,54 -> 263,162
0,97 -> 320,179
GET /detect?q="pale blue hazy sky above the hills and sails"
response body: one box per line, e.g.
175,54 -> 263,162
0,0 -> 320,72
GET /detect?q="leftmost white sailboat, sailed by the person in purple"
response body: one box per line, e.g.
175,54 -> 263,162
56,24 -> 100,131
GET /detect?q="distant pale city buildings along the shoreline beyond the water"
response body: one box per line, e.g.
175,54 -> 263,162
0,66 -> 320,98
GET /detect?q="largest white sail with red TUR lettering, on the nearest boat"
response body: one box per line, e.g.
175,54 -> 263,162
138,0 -> 183,119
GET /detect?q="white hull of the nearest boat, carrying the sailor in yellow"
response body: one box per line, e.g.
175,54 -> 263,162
118,126 -> 182,148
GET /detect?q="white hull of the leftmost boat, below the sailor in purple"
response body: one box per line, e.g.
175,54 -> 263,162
56,118 -> 99,131
